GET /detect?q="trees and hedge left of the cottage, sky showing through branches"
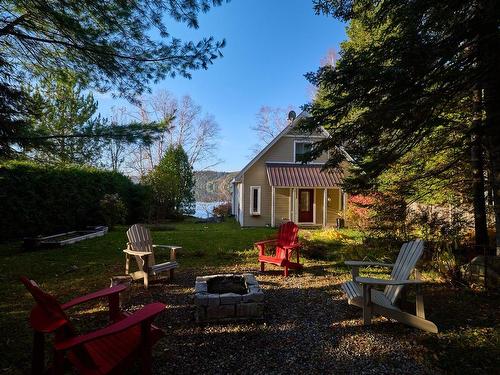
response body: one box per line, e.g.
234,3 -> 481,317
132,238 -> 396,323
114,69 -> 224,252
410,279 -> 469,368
0,0 -> 225,238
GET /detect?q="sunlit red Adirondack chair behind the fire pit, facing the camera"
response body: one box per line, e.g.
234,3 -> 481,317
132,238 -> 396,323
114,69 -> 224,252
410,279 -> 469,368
255,221 -> 302,277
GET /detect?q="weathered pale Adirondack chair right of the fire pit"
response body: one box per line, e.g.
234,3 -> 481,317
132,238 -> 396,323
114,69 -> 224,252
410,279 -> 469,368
342,240 -> 438,333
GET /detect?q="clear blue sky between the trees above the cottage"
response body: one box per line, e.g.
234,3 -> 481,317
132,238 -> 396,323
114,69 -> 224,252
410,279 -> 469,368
96,0 -> 345,171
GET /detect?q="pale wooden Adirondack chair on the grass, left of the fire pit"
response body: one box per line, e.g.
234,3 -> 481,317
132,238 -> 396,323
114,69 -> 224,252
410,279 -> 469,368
123,224 -> 182,288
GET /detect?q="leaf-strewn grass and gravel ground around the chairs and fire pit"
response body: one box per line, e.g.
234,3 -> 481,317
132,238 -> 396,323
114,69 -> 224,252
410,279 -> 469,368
0,220 -> 500,374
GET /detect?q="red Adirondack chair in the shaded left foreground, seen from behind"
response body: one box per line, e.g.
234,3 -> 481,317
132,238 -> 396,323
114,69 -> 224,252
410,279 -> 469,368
21,276 -> 166,374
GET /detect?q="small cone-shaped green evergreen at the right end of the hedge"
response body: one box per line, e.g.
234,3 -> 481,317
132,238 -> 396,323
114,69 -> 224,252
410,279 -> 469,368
144,145 -> 195,220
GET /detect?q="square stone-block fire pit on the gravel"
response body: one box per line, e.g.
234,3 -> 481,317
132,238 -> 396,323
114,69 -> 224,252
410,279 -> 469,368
194,273 -> 264,322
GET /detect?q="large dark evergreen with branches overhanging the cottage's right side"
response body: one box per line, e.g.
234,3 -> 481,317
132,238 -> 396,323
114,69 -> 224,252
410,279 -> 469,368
307,0 -> 500,256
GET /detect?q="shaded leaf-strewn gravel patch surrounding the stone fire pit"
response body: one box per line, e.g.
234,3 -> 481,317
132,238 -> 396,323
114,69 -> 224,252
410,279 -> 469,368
11,264 -> 500,374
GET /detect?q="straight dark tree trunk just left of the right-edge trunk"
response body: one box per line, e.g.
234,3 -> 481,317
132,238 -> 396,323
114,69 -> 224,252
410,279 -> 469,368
471,86 -> 489,254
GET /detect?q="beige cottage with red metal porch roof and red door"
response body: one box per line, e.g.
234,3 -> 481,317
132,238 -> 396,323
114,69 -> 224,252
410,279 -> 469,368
232,112 -> 346,227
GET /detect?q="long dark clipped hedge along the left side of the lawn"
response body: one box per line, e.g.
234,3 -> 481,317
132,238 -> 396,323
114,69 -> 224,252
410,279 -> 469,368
0,161 -> 148,239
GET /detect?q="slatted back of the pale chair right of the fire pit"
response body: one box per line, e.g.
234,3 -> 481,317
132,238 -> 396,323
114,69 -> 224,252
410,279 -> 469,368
384,240 -> 424,304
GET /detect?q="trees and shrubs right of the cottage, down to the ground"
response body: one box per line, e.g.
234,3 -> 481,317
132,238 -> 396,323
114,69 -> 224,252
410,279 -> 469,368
304,0 -> 500,255
